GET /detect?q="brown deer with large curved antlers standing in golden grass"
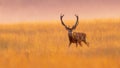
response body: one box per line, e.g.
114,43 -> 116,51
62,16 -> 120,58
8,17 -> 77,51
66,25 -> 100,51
60,15 -> 89,47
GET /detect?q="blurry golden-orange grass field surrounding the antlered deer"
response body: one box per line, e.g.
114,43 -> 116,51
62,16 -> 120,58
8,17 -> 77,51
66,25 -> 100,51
0,20 -> 120,68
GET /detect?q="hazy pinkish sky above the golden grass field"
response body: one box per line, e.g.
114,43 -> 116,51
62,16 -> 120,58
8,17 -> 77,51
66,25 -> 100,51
0,0 -> 120,22
